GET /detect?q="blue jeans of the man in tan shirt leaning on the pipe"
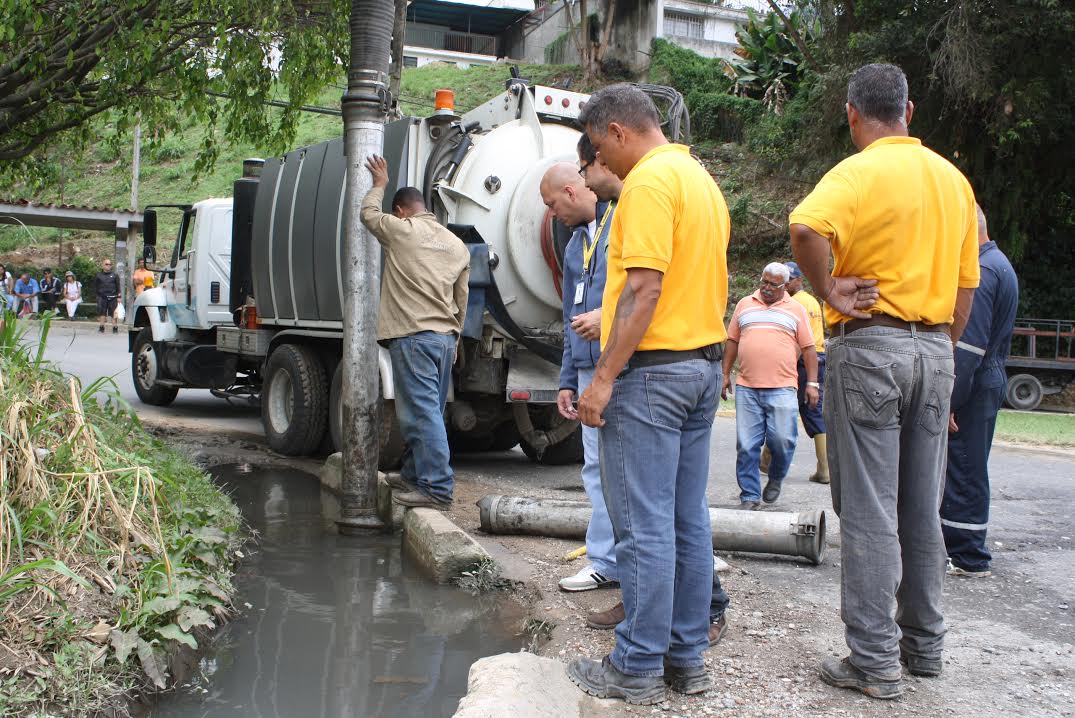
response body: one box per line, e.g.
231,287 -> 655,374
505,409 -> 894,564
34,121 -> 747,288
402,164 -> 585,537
388,331 -> 456,501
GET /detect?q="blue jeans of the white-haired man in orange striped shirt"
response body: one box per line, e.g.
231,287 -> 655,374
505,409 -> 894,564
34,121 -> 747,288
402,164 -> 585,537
735,385 -> 799,501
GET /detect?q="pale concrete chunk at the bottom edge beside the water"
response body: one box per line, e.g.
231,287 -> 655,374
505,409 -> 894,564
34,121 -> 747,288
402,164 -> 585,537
454,652 -> 610,718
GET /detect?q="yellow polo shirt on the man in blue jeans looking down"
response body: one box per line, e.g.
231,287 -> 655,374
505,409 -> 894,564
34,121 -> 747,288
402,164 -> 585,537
601,144 -> 731,350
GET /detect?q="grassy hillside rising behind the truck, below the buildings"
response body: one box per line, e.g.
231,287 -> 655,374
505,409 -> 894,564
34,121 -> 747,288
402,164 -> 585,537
0,56 -> 809,299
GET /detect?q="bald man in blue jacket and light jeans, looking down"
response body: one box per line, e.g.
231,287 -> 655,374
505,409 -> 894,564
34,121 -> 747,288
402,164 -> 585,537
541,162 -> 618,591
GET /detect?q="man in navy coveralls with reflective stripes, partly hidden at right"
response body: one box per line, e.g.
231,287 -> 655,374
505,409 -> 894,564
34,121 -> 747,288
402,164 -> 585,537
941,206 -> 1019,577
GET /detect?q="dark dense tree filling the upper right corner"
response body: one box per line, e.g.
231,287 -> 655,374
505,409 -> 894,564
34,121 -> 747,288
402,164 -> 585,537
801,0 -> 1075,318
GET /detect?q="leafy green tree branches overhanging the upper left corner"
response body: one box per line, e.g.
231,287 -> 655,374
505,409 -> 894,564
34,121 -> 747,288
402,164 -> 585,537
0,0 -> 348,174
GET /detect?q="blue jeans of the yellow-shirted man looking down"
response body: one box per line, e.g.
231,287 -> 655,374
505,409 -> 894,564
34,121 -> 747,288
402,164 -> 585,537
600,359 -> 720,676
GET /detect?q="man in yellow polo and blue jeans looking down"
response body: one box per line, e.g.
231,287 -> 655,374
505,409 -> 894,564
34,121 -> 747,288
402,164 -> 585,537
568,85 -> 730,704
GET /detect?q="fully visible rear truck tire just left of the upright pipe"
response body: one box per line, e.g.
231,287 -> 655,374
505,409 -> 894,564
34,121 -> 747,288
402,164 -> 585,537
261,344 -> 329,456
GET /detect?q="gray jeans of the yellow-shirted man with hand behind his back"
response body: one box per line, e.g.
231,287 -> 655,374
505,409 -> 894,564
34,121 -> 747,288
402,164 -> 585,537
825,327 -> 955,678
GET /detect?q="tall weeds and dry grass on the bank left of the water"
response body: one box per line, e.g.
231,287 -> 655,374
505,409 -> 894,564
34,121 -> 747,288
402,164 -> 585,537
0,315 -> 239,715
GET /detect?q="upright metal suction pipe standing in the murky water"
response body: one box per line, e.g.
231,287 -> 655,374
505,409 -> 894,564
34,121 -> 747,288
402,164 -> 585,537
338,0 -> 396,535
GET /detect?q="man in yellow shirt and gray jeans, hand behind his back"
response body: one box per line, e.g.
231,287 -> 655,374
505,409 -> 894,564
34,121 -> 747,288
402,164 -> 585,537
790,64 -> 978,699
